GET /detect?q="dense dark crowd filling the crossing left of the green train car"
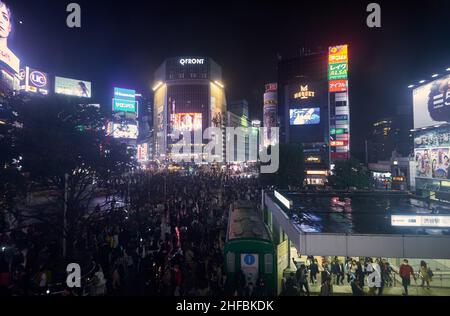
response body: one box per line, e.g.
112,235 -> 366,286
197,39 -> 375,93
0,173 -> 261,296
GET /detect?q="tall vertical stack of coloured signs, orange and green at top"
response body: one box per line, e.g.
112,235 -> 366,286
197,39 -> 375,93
328,45 -> 350,160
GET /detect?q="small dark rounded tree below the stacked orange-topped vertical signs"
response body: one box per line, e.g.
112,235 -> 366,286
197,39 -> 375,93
328,158 -> 370,189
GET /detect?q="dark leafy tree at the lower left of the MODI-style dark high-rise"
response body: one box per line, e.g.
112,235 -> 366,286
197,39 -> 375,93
260,144 -> 305,189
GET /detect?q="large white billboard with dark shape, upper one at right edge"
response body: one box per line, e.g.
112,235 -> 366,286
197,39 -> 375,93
413,75 -> 450,128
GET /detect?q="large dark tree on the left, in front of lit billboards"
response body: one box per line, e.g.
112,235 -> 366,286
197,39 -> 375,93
11,96 -> 134,258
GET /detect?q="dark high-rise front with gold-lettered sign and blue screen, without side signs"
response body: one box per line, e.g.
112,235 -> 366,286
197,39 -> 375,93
278,51 -> 330,185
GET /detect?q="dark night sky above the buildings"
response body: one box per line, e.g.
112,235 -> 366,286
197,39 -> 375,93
5,0 -> 450,156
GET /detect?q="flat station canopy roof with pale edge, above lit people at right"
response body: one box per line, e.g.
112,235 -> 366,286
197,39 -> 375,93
263,191 -> 450,259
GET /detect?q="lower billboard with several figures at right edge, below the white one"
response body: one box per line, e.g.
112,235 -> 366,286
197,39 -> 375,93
414,148 -> 450,179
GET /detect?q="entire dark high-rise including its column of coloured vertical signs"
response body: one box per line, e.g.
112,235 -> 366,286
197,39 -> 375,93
278,45 -> 350,185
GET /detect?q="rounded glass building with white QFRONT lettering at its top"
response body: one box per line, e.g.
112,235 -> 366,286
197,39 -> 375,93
153,57 -> 227,162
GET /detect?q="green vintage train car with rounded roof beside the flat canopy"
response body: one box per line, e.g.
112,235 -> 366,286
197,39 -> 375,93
224,201 -> 277,295
